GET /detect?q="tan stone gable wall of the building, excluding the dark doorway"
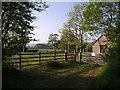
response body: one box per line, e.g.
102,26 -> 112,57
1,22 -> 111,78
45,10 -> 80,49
92,35 -> 107,54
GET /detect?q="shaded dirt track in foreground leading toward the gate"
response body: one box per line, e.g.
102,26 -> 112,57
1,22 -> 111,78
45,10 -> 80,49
31,66 -> 101,88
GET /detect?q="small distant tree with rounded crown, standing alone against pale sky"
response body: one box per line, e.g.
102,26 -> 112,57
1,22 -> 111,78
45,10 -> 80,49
48,34 -> 59,49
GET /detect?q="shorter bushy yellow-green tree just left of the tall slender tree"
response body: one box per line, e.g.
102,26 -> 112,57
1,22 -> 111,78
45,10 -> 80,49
59,22 -> 77,53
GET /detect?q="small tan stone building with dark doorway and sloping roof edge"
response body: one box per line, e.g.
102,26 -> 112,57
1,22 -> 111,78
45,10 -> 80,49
92,35 -> 107,54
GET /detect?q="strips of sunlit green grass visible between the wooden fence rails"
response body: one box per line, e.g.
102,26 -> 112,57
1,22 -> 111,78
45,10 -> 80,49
4,49 -> 64,66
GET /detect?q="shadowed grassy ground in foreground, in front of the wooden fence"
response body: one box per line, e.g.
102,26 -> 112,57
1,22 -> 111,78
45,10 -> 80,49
3,62 -> 102,88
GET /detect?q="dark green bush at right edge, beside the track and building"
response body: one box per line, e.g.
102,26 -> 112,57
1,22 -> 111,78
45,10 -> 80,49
97,45 -> 120,88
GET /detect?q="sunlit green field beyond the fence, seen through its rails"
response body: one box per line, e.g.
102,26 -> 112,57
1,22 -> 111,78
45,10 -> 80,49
6,49 -> 64,66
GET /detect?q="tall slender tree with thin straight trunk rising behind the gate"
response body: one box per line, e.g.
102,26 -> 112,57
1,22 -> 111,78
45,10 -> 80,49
68,3 -> 88,62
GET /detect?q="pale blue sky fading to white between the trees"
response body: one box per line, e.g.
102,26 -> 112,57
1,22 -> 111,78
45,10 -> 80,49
30,2 -> 84,43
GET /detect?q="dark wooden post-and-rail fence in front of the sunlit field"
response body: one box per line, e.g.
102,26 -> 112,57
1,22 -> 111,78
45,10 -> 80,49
4,51 -> 76,69
